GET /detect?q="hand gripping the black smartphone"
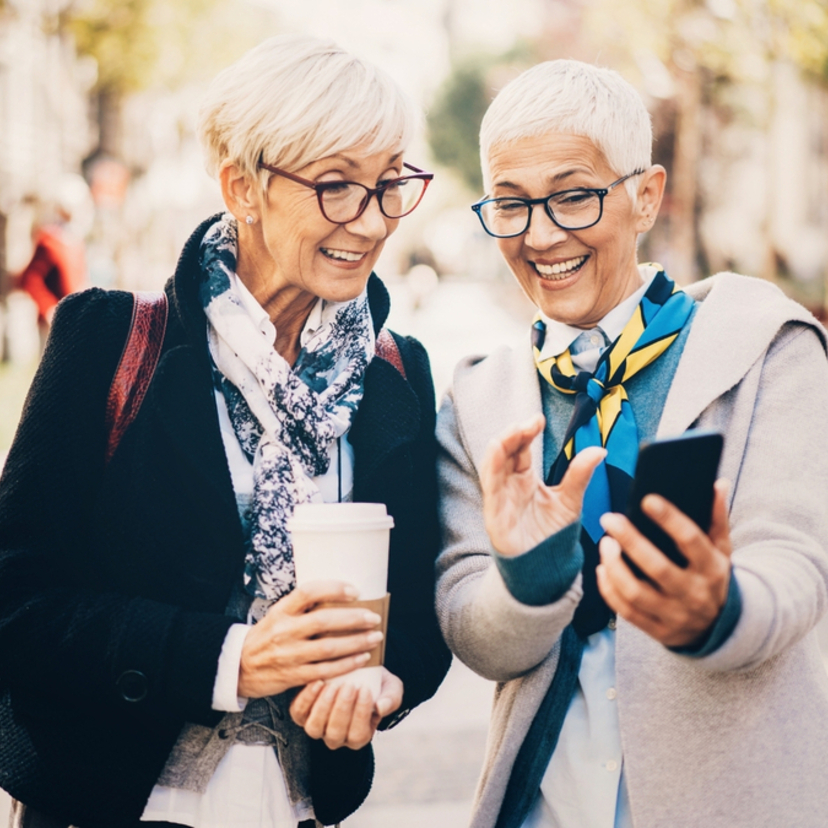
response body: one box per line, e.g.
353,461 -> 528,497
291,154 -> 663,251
597,480 -> 733,647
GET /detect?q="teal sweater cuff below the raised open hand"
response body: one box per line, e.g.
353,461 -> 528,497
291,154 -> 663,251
492,521 -> 584,607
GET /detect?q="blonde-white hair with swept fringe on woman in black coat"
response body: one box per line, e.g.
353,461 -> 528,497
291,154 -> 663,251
198,35 -> 418,187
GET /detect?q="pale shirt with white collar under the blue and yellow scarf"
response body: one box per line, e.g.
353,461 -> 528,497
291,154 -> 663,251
523,266 -> 657,828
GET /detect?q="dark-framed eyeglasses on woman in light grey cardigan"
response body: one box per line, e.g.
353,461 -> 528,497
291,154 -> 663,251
472,169 -> 644,239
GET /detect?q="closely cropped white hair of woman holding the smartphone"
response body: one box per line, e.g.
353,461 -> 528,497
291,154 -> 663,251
480,60 -> 653,198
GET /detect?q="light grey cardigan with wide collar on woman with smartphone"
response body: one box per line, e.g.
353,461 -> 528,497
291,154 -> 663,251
437,273 -> 828,828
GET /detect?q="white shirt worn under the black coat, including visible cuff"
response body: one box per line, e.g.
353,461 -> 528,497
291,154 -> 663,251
141,282 -> 354,828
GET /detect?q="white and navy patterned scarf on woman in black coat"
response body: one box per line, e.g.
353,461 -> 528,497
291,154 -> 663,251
200,214 -> 375,601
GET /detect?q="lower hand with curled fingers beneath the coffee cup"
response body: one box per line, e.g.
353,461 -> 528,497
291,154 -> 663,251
290,667 -> 403,750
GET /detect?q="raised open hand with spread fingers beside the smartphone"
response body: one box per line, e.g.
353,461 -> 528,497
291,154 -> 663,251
480,414 -> 606,556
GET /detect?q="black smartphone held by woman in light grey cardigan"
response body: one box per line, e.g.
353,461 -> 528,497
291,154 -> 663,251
623,429 -> 724,580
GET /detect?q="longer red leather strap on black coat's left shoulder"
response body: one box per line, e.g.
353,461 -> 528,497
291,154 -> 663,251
106,291 -> 169,463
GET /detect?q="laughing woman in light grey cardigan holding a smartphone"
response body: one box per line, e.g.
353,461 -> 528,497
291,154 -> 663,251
437,60 -> 828,828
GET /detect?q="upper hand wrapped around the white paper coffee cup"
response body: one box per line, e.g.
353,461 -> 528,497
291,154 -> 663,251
238,581 -> 382,699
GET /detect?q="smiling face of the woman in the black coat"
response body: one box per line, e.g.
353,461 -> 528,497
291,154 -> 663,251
222,150 -> 403,316
